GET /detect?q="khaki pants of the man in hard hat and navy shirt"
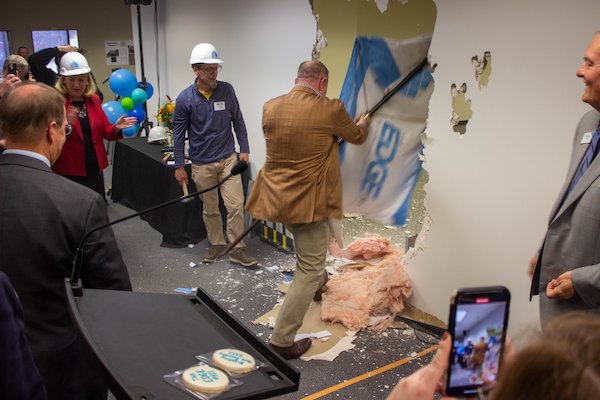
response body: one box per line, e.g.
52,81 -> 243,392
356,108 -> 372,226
192,153 -> 244,248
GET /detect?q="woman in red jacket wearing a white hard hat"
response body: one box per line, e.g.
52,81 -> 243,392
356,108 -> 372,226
52,52 -> 136,198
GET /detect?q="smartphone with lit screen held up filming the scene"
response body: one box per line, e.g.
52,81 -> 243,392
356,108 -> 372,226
445,286 -> 510,397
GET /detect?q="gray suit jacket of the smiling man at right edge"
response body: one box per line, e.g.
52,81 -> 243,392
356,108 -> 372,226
532,110 -> 600,322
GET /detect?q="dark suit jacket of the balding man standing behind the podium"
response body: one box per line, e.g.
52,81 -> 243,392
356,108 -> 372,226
0,154 -> 131,356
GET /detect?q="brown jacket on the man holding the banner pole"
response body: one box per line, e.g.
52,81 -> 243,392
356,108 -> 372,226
246,86 -> 367,224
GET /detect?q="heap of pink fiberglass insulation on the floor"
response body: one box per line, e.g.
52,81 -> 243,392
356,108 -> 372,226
321,251 -> 412,331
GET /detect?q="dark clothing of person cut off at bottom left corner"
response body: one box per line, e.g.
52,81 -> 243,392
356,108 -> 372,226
0,272 -> 46,400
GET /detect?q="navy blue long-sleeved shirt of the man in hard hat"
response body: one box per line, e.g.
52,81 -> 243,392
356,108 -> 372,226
173,81 -> 250,168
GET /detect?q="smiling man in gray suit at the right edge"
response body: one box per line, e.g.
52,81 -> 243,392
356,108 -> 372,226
529,32 -> 600,323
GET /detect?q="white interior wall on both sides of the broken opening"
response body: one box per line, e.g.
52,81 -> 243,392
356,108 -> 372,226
134,0 -> 600,332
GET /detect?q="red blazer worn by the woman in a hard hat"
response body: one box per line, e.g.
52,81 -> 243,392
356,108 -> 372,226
52,94 -> 123,176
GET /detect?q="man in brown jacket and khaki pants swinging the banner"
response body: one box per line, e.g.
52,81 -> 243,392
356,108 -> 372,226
246,60 -> 369,359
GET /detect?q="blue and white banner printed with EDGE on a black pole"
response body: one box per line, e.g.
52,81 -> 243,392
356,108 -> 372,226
340,35 -> 433,225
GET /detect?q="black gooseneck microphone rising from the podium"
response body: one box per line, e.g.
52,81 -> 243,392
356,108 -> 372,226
67,160 -> 248,297
